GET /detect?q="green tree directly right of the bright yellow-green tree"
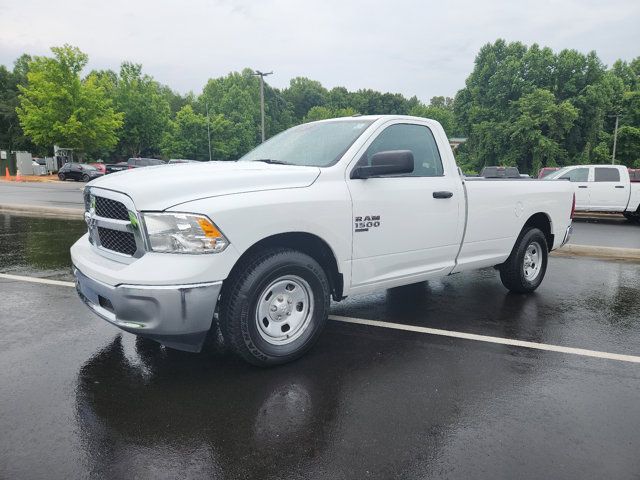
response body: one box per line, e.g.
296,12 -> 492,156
112,62 -> 171,157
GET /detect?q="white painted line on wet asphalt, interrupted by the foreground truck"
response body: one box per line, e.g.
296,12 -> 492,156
0,273 -> 640,363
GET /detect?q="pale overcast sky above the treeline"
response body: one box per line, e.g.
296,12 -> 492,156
0,0 -> 640,101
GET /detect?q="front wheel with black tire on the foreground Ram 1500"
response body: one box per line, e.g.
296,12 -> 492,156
219,248 -> 330,367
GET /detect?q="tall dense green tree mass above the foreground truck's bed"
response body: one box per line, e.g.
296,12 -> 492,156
456,40 -> 640,174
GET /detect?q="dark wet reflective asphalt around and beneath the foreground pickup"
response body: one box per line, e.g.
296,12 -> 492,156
0,215 -> 640,479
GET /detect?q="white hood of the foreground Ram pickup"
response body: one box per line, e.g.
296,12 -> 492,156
88,162 -> 320,210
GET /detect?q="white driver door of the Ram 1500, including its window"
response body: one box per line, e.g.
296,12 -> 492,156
347,123 -> 464,292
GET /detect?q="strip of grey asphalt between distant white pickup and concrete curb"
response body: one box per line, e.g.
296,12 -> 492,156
569,216 -> 640,248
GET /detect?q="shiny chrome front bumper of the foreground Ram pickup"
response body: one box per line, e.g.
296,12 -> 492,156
73,266 -> 222,352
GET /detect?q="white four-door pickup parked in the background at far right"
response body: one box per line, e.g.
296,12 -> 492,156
544,165 -> 640,220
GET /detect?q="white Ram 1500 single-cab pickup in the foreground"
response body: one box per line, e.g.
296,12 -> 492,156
71,116 -> 574,365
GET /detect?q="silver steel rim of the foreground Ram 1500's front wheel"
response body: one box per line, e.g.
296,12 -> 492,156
255,275 -> 313,345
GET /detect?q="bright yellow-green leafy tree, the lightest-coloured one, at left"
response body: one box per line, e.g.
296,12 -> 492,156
16,45 -> 122,156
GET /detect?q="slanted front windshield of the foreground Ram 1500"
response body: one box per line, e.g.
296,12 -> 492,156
240,119 -> 373,167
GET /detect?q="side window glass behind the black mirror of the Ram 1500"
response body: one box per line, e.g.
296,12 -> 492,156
358,123 -> 444,177
